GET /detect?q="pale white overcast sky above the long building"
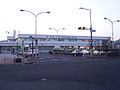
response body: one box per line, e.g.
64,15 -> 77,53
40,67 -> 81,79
0,0 -> 120,40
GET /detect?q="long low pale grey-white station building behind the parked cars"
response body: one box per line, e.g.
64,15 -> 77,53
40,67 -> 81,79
0,32 -> 111,53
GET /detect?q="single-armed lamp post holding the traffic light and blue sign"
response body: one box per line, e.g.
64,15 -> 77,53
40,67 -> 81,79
79,7 -> 93,57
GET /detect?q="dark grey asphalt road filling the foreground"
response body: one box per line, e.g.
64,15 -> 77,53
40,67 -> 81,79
0,54 -> 120,90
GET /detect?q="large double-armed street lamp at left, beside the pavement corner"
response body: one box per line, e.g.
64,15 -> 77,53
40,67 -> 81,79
20,9 -> 50,58
